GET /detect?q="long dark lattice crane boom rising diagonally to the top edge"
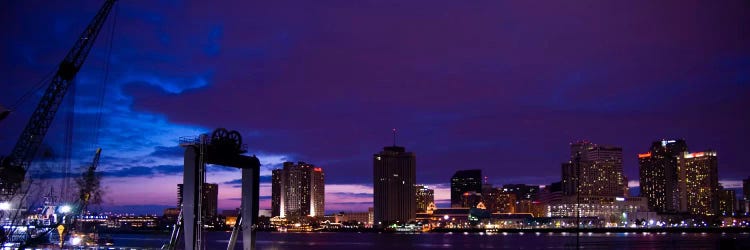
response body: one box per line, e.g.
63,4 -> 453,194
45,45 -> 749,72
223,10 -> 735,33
0,0 -> 116,197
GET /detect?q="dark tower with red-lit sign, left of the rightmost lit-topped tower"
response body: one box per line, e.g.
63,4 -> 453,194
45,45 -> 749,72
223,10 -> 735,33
638,140 -> 687,213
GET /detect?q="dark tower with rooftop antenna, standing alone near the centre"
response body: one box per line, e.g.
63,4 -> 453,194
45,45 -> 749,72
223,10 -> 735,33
373,145 -> 417,227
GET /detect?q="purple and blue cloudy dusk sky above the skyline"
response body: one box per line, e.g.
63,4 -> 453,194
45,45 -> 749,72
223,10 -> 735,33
0,0 -> 750,213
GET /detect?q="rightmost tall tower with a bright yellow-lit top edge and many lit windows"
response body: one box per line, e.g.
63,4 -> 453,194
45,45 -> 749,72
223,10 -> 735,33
677,151 -> 719,215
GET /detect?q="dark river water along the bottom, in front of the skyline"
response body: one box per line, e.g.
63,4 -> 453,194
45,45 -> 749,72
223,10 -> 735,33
106,232 -> 750,250
